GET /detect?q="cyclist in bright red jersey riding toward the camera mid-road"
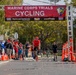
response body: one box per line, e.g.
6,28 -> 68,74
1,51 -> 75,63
33,37 -> 41,59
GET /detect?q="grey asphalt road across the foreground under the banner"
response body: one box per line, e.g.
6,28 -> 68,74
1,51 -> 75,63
0,58 -> 76,75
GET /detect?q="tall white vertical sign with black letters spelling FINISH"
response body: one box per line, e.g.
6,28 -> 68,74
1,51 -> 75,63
67,4 -> 73,40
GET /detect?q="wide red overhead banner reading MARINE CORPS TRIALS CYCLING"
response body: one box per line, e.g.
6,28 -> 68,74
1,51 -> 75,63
5,5 -> 66,21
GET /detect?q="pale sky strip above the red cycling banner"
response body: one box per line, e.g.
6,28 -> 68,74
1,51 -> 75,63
22,0 -> 71,5
